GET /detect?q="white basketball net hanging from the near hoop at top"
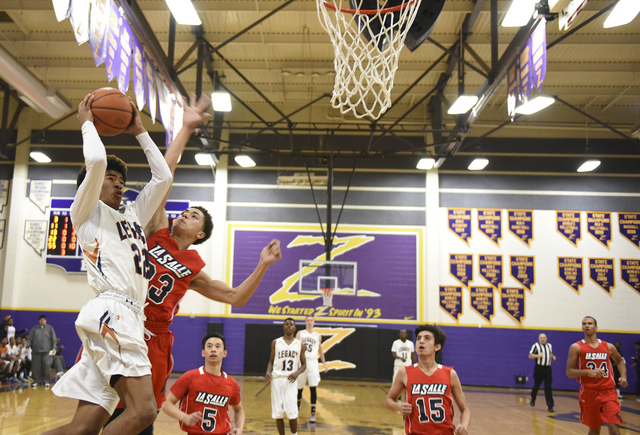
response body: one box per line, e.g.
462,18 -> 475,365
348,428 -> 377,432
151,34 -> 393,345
317,0 -> 420,119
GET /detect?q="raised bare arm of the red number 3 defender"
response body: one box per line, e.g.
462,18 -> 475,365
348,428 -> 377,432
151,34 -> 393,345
144,94 -> 211,237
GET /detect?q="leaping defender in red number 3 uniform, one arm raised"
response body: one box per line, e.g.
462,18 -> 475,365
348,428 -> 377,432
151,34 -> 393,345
110,94 -> 281,435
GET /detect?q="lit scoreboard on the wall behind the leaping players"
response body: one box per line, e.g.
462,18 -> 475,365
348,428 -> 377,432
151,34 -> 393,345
46,196 -> 190,273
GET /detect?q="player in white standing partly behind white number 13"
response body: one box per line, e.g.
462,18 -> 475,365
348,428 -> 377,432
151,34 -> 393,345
296,315 -> 329,423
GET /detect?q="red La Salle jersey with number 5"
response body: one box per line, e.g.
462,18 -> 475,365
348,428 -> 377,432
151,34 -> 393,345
171,367 -> 240,434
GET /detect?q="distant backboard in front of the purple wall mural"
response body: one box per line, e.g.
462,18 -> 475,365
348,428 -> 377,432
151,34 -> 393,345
298,260 -> 358,296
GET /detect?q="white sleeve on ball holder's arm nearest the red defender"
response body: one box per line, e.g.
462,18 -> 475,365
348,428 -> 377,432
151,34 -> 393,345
134,132 -> 172,228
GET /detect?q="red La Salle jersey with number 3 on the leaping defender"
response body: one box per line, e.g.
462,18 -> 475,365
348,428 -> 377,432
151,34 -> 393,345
144,228 -> 205,323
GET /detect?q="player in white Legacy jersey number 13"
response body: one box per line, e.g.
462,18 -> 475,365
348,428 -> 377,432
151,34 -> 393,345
264,317 -> 307,435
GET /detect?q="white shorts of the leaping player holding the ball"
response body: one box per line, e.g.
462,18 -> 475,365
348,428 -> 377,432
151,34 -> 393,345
52,291 -> 151,414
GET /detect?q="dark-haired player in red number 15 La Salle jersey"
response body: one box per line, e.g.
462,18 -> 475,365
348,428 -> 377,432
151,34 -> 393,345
385,325 -> 471,435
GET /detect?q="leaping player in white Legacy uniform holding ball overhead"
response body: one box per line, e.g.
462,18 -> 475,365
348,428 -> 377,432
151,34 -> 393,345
47,94 -> 172,435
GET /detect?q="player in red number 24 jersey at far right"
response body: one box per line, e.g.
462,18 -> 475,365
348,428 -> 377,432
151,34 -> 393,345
567,316 -> 628,435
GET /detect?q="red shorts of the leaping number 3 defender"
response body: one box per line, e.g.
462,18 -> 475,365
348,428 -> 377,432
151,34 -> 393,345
144,331 -> 174,409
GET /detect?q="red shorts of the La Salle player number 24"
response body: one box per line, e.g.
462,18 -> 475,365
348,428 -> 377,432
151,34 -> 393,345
578,385 -> 622,429
